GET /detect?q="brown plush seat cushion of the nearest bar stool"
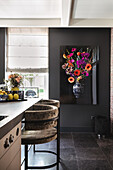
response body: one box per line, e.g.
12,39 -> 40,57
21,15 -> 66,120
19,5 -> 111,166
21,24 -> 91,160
21,128 -> 57,145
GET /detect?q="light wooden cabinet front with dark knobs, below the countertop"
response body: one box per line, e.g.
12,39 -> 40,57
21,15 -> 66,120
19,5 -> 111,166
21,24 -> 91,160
0,123 -> 21,170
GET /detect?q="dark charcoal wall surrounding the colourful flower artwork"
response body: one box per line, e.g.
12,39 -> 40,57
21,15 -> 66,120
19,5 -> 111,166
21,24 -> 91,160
49,28 -> 110,131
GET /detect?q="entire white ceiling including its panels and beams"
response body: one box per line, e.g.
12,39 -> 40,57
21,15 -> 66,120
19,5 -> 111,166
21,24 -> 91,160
0,0 -> 113,27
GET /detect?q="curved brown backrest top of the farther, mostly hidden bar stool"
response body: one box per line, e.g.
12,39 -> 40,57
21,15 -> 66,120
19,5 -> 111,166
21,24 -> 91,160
38,99 -> 60,108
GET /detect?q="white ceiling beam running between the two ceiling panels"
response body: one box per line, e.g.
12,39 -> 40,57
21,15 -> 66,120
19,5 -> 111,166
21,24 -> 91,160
61,0 -> 72,26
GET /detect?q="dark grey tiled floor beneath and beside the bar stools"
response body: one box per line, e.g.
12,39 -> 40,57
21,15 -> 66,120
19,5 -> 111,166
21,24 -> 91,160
21,133 -> 113,170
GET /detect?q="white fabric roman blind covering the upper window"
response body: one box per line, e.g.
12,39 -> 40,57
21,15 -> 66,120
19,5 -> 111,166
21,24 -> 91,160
7,28 -> 48,73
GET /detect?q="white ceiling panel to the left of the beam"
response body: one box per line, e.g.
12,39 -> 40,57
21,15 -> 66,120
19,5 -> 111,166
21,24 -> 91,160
0,0 -> 61,18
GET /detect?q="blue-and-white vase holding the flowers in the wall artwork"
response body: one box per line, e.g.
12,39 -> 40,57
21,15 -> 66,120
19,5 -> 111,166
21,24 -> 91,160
73,81 -> 84,98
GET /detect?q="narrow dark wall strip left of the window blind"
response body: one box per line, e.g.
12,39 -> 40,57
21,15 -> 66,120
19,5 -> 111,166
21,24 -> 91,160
0,28 -> 5,84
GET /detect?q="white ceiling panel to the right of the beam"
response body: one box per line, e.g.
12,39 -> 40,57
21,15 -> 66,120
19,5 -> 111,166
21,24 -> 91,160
73,0 -> 113,19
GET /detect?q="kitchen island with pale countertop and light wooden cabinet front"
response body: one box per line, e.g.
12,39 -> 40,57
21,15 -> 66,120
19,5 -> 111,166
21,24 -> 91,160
0,98 -> 40,170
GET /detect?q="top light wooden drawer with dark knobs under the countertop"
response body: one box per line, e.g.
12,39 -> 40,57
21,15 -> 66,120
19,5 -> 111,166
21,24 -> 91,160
0,123 -> 21,159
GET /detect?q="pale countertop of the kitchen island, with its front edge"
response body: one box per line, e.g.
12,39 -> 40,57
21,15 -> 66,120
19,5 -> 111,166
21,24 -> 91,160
0,98 -> 41,139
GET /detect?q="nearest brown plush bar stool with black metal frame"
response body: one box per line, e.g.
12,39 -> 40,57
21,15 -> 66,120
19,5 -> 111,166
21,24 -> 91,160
21,104 -> 60,170
